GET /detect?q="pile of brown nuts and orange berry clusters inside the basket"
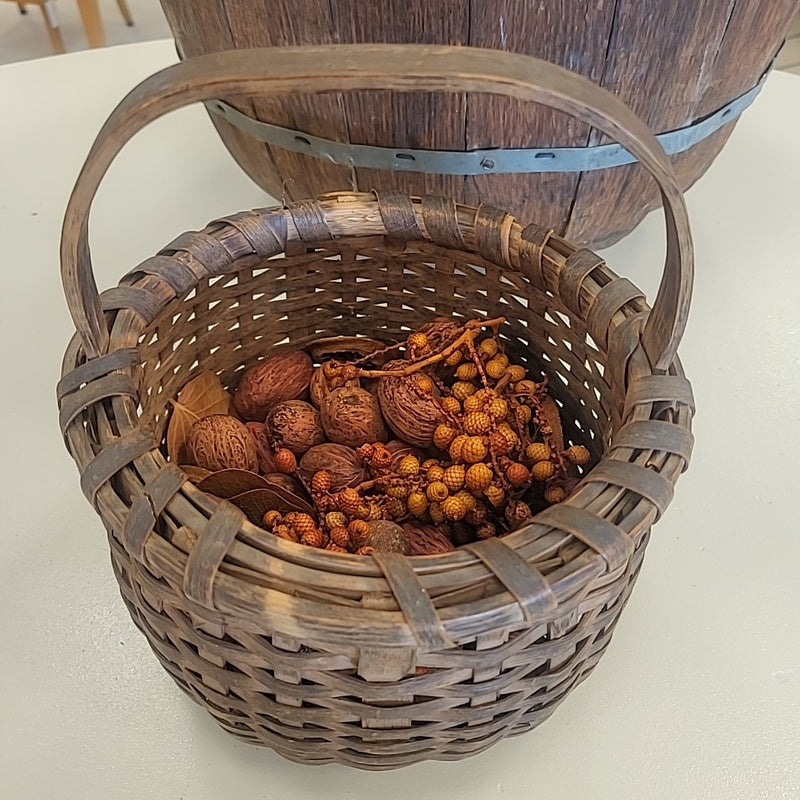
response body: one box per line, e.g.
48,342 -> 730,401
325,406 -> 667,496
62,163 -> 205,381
167,318 -> 590,554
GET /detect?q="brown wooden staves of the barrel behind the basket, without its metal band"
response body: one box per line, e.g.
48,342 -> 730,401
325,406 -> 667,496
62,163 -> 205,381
162,0 -> 796,247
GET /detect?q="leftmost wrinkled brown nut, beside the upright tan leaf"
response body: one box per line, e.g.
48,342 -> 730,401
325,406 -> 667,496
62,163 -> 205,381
186,414 -> 258,472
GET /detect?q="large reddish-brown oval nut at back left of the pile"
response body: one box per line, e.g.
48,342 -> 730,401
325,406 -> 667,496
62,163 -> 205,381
233,350 -> 314,422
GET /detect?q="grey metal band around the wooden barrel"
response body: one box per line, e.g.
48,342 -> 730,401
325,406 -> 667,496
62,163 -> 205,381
206,70 -> 769,175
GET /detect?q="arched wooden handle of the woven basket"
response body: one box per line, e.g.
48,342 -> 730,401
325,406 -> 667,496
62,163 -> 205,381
61,44 -> 694,369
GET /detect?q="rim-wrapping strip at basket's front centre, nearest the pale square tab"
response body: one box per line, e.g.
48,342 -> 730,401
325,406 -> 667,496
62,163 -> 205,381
372,553 -> 453,651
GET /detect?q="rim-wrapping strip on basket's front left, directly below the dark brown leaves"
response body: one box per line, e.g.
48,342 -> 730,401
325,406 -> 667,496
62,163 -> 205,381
183,503 -> 245,609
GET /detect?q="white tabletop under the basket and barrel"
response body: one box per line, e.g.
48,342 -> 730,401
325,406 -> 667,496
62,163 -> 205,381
0,41 -> 800,800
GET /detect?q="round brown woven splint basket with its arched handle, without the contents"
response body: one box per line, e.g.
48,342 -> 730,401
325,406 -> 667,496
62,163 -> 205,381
58,46 -> 692,769
